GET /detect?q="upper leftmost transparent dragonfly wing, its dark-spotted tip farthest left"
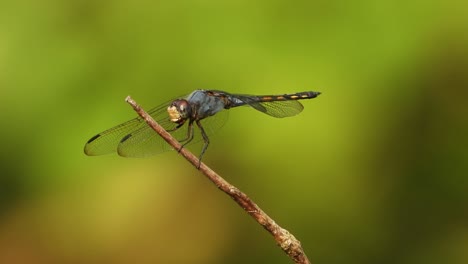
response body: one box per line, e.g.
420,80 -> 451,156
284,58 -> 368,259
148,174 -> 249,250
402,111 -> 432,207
84,97 -> 176,156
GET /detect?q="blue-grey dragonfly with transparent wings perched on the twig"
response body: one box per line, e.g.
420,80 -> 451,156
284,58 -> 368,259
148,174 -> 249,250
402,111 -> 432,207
84,90 -> 320,165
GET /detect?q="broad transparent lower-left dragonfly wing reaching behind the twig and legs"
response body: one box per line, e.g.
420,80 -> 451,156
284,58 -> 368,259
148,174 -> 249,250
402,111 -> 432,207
117,107 -> 228,157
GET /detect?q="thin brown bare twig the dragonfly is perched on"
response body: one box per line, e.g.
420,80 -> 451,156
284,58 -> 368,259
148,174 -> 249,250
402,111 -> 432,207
125,96 -> 310,264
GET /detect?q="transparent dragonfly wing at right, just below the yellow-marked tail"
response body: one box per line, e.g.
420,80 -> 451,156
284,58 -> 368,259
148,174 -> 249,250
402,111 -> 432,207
236,95 -> 304,118
